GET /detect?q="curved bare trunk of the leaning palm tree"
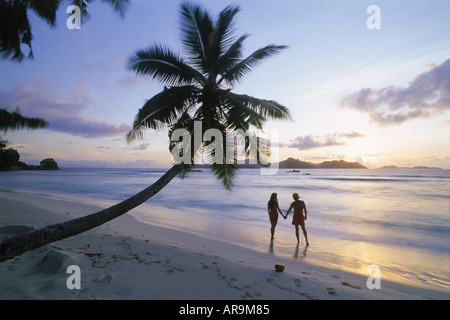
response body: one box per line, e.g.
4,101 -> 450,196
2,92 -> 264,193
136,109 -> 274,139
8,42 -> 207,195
0,164 -> 184,262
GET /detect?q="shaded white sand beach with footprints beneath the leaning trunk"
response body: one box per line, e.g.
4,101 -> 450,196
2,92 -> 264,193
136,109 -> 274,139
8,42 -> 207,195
0,190 -> 449,300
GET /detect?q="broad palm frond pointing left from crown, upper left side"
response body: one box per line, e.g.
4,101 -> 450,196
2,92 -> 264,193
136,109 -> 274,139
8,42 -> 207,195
128,45 -> 203,86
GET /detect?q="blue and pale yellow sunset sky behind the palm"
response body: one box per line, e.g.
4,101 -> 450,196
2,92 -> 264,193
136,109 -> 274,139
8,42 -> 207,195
0,0 -> 450,169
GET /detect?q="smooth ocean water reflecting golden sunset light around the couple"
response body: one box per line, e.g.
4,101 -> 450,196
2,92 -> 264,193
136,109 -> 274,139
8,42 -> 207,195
0,168 -> 450,292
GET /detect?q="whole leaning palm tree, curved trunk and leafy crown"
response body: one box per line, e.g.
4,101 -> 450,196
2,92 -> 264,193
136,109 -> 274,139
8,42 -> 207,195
0,5 -> 290,261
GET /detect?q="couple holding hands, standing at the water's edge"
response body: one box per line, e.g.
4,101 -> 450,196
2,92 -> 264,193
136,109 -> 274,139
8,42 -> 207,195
267,193 -> 309,246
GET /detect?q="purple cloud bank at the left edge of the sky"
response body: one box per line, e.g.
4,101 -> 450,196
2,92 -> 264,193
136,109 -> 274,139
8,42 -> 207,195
0,80 -> 131,138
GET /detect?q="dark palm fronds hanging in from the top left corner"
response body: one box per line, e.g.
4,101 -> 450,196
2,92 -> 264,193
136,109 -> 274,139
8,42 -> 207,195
0,0 -> 129,61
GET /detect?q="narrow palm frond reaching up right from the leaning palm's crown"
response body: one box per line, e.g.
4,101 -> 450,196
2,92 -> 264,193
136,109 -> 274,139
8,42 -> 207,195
219,45 -> 287,86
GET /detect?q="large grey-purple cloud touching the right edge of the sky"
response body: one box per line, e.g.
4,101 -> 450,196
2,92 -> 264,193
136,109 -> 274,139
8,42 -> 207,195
341,59 -> 450,126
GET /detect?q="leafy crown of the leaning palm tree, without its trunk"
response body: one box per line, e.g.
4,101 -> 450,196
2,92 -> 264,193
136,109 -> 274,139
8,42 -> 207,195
128,5 -> 289,189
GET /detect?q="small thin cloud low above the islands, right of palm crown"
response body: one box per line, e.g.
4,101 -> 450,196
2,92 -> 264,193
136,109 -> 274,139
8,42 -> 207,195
283,131 -> 365,150
